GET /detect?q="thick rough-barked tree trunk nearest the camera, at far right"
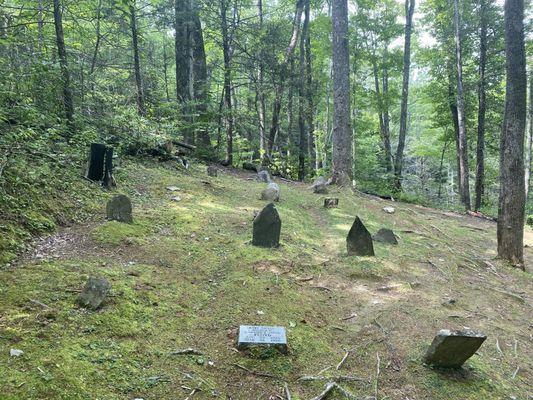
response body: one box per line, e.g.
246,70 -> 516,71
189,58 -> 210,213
498,0 -> 527,269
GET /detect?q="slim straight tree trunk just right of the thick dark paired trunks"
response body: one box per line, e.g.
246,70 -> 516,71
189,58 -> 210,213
219,0 -> 233,165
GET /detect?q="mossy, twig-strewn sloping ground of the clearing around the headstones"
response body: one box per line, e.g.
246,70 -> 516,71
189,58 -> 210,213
0,161 -> 533,400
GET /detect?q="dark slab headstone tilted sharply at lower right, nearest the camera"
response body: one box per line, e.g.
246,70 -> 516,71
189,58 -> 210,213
424,329 -> 487,368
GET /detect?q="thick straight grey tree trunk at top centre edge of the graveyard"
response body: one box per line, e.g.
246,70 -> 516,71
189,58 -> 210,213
332,0 -> 352,185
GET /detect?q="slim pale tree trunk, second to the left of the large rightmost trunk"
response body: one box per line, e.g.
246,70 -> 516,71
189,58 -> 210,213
453,0 -> 470,210
